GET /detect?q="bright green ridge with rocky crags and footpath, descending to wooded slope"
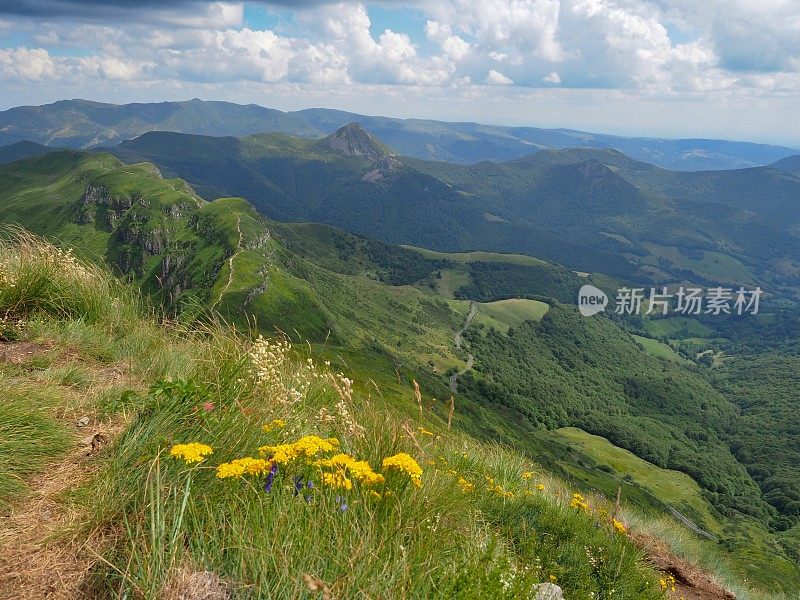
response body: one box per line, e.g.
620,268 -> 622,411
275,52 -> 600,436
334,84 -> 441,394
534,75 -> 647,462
0,150 -> 800,598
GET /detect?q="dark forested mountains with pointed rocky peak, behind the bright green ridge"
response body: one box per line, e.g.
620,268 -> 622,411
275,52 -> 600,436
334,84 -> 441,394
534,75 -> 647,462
112,130 -> 800,295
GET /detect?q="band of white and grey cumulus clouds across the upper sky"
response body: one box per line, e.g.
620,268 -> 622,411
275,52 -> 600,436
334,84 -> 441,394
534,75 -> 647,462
0,0 -> 800,108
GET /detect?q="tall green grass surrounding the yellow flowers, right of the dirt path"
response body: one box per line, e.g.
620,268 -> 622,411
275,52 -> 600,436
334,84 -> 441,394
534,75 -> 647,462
81,331 -> 662,599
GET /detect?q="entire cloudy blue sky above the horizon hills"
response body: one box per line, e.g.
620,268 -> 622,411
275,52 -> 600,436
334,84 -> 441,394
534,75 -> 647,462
0,0 -> 800,148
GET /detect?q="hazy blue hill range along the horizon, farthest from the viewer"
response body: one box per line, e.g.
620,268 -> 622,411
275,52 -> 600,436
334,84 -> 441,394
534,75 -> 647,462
0,99 -> 798,171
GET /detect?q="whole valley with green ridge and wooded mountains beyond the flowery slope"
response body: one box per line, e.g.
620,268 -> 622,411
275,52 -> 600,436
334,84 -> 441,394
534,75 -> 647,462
0,116 -> 800,598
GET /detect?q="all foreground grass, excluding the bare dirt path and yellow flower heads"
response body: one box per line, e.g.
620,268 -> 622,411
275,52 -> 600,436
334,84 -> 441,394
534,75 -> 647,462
0,231 -> 676,600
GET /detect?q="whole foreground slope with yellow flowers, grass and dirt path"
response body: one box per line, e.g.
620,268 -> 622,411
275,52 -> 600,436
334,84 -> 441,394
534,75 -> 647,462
0,234 -> 688,600
